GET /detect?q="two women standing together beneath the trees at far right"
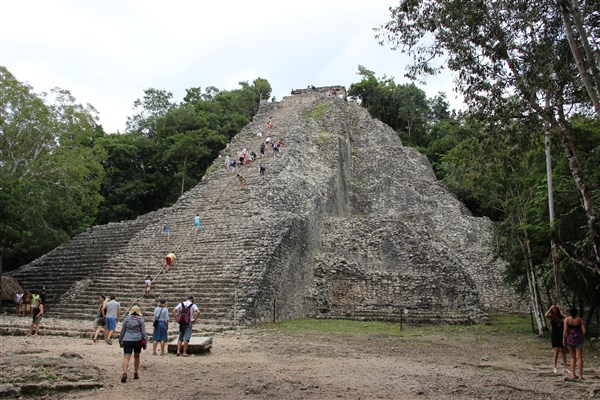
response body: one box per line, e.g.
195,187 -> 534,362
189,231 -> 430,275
546,304 -> 587,380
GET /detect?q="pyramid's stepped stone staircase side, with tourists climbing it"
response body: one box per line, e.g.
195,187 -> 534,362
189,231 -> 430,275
5,94 -> 324,326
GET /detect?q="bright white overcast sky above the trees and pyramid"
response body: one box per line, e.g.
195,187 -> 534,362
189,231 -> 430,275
0,0 -> 461,132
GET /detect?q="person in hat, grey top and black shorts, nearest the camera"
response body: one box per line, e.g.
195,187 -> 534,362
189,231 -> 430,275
119,306 -> 148,383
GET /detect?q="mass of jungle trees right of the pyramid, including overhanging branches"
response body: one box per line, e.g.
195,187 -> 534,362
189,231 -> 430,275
366,0 -> 600,328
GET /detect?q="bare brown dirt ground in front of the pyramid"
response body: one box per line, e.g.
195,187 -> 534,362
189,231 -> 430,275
0,316 -> 600,400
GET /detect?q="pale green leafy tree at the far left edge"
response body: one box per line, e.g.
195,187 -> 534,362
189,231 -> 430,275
0,67 -> 105,269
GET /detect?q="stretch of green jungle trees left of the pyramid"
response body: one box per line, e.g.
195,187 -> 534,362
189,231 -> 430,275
0,67 -> 271,270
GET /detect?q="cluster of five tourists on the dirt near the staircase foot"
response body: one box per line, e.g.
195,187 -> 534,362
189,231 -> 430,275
92,295 -> 200,383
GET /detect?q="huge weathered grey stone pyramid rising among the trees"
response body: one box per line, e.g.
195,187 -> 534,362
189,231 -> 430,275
9,93 -> 514,329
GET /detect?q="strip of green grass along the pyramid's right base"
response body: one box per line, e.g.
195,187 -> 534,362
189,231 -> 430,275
260,315 -> 534,337
